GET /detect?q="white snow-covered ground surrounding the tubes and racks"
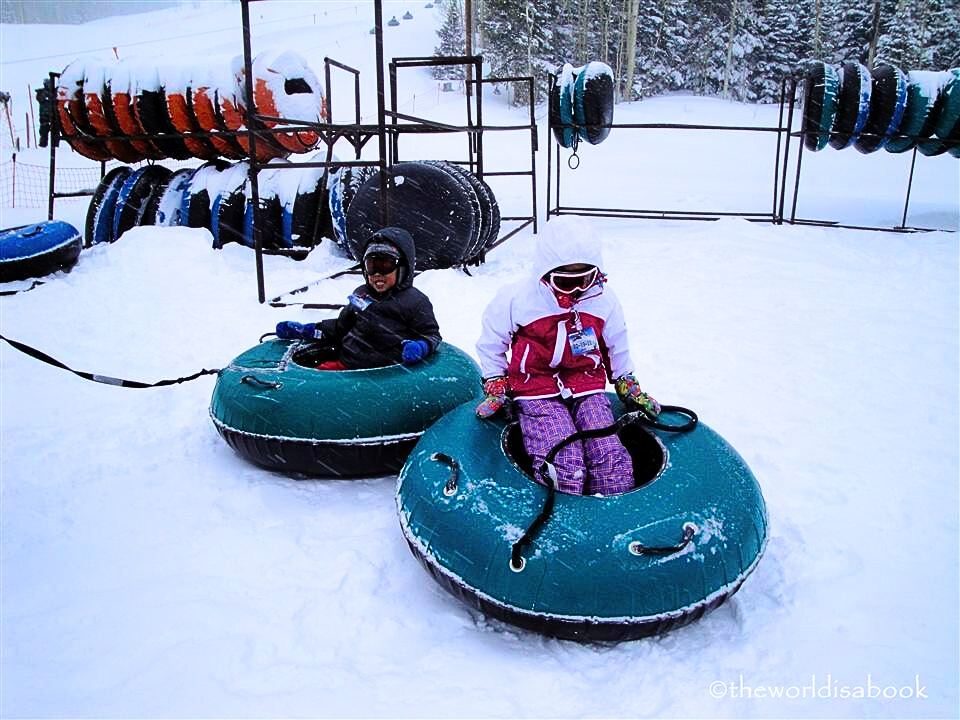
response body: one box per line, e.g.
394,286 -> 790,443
0,2 -> 960,717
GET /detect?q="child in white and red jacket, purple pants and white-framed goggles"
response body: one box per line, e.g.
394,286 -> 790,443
477,216 -> 660,495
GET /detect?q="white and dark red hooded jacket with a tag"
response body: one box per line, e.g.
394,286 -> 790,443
477,216 -> 633,399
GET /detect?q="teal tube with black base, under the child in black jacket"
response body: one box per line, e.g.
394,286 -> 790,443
210,339 -> 480,477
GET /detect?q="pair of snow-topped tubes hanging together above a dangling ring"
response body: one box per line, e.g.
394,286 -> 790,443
549,61 -> 613,148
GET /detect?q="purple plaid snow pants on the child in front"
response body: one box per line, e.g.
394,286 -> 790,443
516,393 -> 633,495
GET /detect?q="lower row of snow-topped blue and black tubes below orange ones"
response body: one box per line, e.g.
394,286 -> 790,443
85,155 -> 333,259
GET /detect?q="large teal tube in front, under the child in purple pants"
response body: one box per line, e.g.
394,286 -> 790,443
397,395 -> 767,641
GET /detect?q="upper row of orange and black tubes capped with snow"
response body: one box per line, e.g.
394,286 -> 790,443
56,51 -> 327,163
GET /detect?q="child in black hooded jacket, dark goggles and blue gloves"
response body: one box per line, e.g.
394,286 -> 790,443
277,227 -> 440,370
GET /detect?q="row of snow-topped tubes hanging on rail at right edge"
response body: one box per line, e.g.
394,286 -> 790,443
801,61 -> 960,156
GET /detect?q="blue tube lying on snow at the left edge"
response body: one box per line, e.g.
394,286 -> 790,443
0,220 -> 83,282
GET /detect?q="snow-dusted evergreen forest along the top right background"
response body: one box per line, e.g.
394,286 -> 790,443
438,0 -> 960,101
